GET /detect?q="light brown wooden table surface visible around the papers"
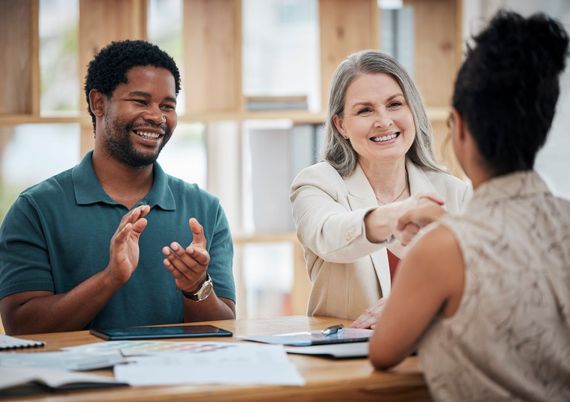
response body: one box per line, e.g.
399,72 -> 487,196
4,316 -> 431,402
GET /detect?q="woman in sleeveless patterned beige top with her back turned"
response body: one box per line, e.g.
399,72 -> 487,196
370,11 -> 570,401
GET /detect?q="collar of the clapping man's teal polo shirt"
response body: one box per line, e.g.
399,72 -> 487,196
71,151 -> 176,211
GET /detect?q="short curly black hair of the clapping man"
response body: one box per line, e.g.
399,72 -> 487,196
85,40 -> 180,130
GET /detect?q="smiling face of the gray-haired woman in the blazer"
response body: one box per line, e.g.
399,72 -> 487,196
333,73 -> 416,164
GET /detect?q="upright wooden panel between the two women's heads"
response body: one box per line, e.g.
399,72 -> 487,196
404,0 -> 462,106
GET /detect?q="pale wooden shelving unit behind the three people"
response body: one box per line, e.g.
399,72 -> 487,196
0,0 -> 462,313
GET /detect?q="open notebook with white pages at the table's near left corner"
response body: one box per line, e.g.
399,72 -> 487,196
0,367 -> 127,397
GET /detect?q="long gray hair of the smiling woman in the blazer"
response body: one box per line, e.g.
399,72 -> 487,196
322,50 -> 442,177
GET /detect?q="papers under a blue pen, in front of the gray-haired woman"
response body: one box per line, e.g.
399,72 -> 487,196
240,328 -> 374,346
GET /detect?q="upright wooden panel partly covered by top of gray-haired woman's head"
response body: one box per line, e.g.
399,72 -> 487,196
319,0 -> 378,110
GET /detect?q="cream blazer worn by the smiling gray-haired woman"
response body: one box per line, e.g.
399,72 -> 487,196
290,160 -> 471,320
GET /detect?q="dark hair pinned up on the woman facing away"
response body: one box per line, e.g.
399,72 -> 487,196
453,10 -> 568,174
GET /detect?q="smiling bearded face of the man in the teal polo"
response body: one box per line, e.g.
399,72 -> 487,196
97,66 -> 177,167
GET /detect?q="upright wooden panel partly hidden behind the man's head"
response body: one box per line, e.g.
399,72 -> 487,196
79,0 -> 147,155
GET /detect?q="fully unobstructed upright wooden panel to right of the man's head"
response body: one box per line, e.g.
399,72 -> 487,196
182,0 -> 243,114
